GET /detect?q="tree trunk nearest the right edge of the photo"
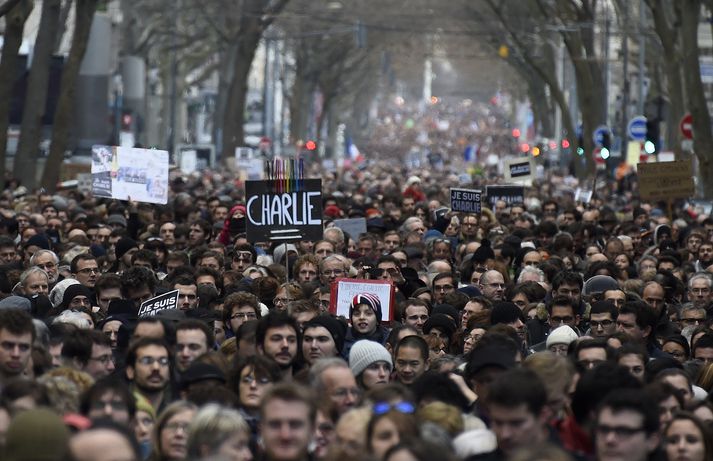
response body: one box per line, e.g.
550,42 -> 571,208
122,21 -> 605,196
681,0 -> 713,199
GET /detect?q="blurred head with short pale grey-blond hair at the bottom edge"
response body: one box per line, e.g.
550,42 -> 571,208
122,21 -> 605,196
186,403 -> 253,461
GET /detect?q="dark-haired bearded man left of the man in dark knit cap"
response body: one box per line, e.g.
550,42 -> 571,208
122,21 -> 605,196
255,312 -> 299,381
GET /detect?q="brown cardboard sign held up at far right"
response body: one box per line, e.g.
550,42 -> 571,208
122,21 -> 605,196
637,158 -> 696,200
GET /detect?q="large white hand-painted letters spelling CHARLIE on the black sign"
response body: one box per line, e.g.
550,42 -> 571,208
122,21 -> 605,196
247,192 -> 321,226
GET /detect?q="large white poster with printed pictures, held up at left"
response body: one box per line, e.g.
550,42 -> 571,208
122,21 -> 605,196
92,146 -> 168,205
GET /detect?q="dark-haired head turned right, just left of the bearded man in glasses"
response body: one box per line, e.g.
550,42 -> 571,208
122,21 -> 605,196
62,329 -> 115,379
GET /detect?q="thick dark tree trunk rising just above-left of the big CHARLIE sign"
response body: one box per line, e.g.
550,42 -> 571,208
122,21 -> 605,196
223,31 -> 261,164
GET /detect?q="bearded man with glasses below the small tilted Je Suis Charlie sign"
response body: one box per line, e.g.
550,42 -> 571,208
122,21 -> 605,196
126,338 -> 172,414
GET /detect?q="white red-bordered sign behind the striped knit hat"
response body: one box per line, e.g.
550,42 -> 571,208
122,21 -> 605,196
329,279 -> 396,322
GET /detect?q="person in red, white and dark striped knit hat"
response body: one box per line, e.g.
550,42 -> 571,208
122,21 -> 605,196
342,293 -> 389,358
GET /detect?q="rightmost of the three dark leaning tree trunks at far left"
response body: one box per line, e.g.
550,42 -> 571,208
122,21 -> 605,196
42,0 -> 99,192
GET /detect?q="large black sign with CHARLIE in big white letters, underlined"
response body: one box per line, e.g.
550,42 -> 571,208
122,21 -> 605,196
245,179 -> 322,242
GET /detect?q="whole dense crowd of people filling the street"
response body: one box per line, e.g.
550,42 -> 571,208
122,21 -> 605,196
0,100 -> 713,461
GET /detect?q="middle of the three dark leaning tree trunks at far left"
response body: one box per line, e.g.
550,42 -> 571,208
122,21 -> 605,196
14,0 -> 62,189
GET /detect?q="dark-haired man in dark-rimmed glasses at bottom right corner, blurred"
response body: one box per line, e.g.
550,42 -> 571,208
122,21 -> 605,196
594,389 -> 659,461
